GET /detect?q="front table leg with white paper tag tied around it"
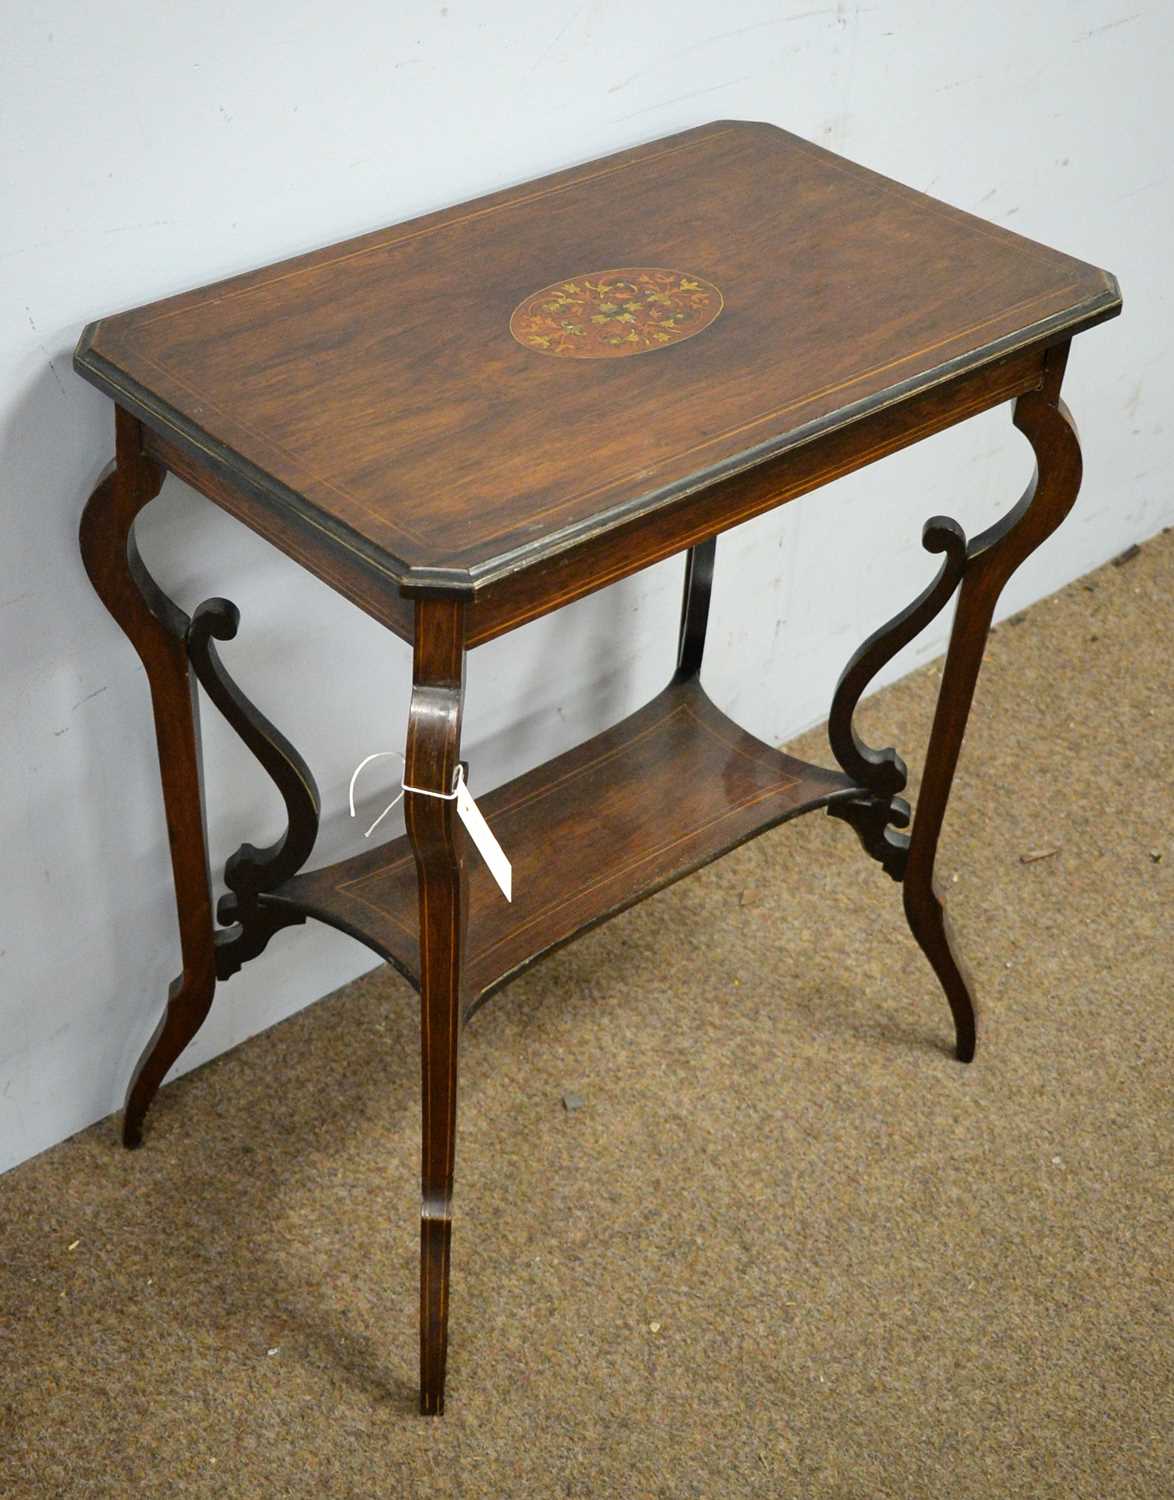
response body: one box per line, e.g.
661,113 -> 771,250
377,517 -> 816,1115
403,600 -> 468,1416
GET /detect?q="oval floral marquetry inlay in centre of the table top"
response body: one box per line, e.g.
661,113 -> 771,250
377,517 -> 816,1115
510,266 -> 723,360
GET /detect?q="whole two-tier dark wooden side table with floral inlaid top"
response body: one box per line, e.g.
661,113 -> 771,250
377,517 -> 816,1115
75,122 -> 1120,1413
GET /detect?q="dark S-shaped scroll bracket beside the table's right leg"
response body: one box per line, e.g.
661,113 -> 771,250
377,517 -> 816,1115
828,516 -> 967,881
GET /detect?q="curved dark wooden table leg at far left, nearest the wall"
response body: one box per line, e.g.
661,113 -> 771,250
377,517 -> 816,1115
79,408 -> 216,1146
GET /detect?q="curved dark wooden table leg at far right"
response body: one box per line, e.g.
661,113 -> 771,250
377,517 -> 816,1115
904,345 -> 1081,1062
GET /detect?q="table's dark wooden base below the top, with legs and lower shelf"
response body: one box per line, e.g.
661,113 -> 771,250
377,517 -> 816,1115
78,120 -> 1120,1413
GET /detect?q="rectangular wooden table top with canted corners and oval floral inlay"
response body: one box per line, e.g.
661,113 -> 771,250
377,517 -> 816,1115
75,120 -> 1120,591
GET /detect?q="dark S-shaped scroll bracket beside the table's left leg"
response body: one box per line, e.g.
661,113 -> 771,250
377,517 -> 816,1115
187,599 -> 321,980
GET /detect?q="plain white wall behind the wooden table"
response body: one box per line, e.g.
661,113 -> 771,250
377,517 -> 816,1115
0,0 -> 1174,1169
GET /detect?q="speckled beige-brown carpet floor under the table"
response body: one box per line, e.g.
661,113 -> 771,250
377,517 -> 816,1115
0,536 -> 1174,1500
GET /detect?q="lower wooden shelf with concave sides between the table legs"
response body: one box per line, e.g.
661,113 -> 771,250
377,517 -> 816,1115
262,678 -> 861,1014
